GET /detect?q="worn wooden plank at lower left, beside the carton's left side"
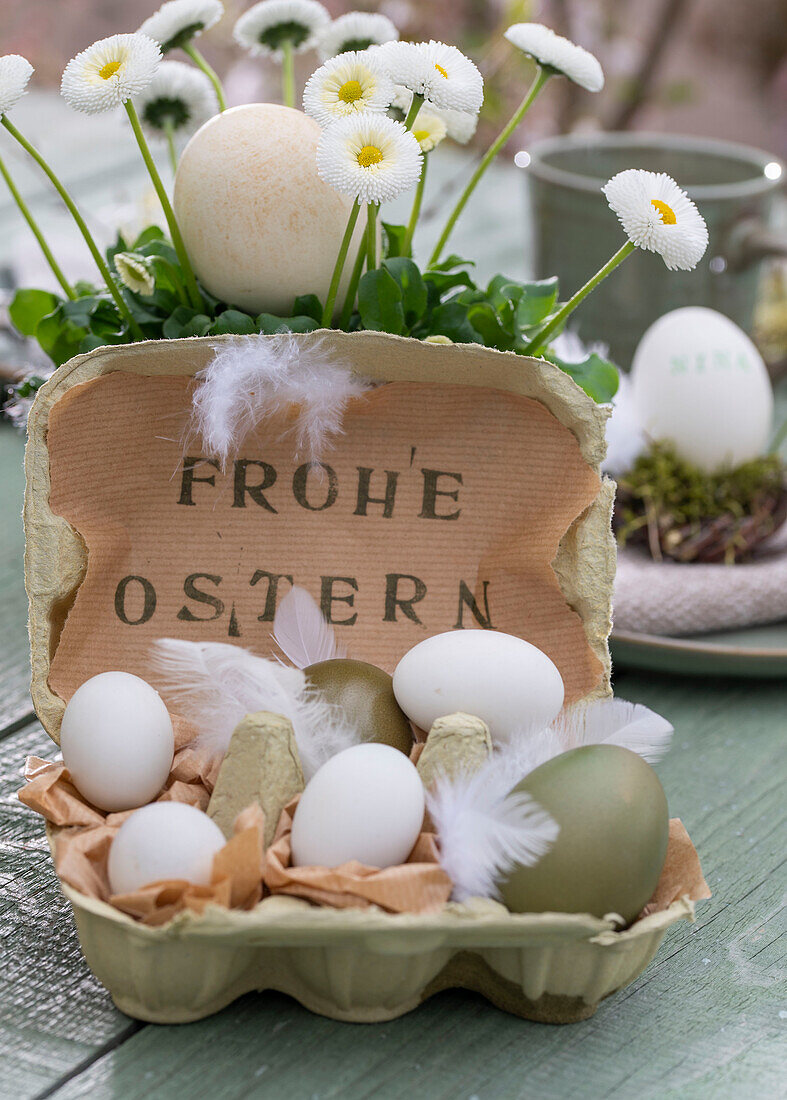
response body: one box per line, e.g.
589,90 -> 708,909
0,723 -> 139,1100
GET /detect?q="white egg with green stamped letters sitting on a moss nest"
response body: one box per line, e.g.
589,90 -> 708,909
632,306 -> 774,471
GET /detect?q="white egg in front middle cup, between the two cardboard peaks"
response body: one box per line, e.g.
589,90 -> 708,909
291,744 -> 424,867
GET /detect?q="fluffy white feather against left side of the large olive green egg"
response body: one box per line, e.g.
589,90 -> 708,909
426,758 -> 559,901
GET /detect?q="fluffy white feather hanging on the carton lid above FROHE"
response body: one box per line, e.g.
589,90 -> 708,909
186,332 -> 371,468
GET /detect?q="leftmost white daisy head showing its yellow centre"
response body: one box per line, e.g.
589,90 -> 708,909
61,34 -> 161,114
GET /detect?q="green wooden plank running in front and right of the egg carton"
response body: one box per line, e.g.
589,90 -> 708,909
23,675 -> 786,1100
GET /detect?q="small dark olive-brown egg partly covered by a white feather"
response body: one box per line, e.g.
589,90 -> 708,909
304,658 -> 413,754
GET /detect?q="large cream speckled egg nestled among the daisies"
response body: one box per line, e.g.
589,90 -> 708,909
174,103 -> 365,314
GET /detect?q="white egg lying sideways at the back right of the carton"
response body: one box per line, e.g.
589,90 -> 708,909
393,630 -> 564,741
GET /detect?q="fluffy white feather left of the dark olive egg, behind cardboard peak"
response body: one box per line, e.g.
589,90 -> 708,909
152,638 -> 361,779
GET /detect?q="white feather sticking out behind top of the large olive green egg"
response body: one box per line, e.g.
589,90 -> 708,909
553,699 -> 674,763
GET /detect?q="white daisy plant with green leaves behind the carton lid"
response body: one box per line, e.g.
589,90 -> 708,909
0,0 -> 708,415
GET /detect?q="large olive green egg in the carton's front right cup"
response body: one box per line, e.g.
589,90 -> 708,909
500,745 -> 669,924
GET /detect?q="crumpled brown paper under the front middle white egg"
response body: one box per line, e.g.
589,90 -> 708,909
264,795 -> 453,913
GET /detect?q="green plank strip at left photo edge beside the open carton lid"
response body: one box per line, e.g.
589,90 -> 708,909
0,424 -> 33,730
